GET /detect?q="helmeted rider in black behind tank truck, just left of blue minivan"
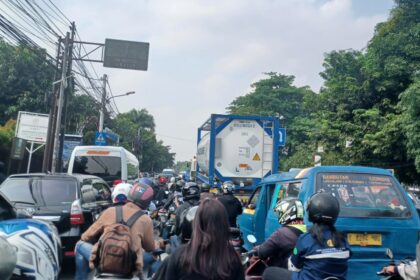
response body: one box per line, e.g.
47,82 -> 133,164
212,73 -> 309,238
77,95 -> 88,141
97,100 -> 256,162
217,181 -> 242,227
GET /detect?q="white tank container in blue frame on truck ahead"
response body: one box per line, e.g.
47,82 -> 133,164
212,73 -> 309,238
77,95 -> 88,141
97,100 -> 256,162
195,114 -> 280,195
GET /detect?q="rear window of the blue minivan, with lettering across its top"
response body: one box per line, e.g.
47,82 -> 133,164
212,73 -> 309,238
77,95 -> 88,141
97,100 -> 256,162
316,173 -> 411,218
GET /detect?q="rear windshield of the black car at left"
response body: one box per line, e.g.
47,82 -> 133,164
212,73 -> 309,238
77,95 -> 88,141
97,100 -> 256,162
0,177 -> 77,206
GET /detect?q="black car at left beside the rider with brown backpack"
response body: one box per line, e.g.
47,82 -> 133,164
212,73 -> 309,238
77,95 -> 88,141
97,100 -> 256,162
0,174 -> 111,257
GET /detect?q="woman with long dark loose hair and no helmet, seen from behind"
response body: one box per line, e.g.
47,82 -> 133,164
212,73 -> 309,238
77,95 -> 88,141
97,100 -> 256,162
165,199 -> 245,280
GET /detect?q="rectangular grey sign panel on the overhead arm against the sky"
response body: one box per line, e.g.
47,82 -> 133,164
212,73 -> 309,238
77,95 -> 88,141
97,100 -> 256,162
104,39 -> 150,71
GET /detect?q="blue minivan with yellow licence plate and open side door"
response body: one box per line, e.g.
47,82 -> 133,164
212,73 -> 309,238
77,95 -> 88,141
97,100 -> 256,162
238,166 -> 420,280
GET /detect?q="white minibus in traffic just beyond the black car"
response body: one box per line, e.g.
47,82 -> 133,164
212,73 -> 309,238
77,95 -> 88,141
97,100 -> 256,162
67,146 -> 139,186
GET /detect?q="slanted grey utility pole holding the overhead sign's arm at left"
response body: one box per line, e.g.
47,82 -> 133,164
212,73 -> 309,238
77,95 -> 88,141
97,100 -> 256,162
51,32 -> 70,173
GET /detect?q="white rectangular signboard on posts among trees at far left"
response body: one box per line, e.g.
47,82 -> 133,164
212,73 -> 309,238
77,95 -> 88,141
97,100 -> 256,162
16,111 -> 48,143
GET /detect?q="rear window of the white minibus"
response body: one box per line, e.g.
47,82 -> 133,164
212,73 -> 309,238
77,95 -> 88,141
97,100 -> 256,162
73,156 -> 121,180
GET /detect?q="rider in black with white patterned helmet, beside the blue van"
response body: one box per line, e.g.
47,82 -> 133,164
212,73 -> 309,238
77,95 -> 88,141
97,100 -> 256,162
255,198 -> 306,268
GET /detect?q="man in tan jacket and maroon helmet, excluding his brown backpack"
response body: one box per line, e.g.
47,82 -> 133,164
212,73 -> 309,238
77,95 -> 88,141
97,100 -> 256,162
75,183 -> 160,280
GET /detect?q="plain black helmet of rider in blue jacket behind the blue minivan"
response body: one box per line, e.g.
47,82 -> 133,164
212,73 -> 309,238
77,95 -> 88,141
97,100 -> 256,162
306,192 -> 340,225
